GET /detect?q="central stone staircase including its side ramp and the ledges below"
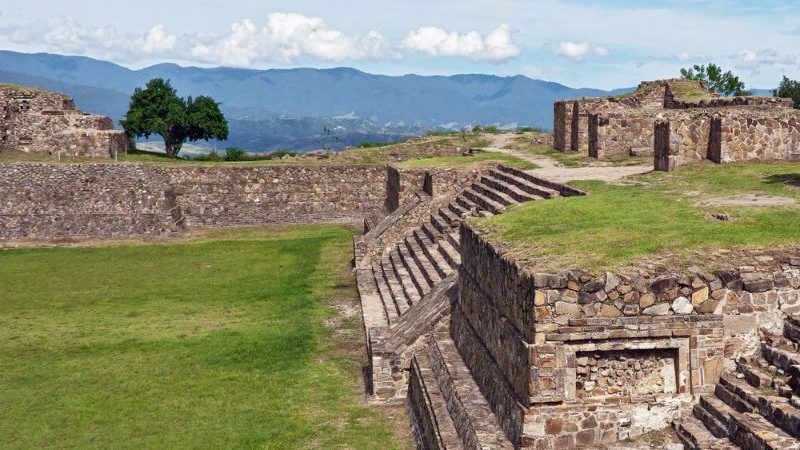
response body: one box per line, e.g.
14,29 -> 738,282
356,166 -> 584,449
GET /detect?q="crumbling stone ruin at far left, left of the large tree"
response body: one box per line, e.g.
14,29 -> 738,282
0,84 -> 129,158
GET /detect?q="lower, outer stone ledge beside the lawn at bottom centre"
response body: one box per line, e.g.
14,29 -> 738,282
406,352 -> 463,449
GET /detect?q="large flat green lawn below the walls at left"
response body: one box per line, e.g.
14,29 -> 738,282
0,226 -> 406,449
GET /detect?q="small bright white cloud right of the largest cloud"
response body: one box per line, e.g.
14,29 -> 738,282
401,24 -> 520,62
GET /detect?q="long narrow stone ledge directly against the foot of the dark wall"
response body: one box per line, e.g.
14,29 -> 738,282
427,326 -> 514,449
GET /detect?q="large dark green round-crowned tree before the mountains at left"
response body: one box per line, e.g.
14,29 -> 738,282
120,78 -> 228,158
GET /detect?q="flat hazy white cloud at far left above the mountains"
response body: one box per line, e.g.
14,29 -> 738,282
7,17 -> 177,60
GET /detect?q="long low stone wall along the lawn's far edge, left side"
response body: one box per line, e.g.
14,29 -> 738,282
0,164 -> 386,239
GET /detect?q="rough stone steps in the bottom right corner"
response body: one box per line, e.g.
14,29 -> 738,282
673,317 -> 800,450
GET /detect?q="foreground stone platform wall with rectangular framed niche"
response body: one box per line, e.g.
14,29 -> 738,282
451,224 -> 800,449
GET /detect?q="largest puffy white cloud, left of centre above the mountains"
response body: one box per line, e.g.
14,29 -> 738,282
191,13 -> 386,67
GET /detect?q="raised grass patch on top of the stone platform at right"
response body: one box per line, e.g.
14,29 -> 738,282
473,163 -> 800,269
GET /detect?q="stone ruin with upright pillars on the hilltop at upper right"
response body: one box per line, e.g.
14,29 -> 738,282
553,80 -> 800,171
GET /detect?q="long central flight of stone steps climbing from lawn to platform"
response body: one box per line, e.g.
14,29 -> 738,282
358,166 -> 561,326
